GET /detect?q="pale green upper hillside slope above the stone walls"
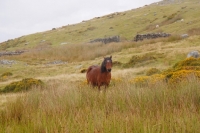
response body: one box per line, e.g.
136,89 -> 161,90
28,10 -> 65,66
0,0 -> 200,50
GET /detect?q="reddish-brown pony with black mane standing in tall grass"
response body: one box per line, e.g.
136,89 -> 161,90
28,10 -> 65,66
86,56 -> 112,90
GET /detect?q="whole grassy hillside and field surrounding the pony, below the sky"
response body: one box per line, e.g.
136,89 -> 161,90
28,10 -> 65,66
0,0 -> 200,133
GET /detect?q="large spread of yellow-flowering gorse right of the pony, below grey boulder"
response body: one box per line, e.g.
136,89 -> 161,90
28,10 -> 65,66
131,58 -> 200,86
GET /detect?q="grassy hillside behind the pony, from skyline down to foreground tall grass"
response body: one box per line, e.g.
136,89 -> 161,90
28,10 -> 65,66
0,0 -> 200,86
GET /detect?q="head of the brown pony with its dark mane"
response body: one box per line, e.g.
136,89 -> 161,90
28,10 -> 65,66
101,56 -> 112,73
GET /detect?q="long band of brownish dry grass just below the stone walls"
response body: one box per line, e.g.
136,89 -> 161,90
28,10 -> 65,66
1,35 -> 181,64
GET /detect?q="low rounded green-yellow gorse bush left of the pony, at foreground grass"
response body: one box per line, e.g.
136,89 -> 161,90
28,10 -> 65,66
1,78 -> 43,93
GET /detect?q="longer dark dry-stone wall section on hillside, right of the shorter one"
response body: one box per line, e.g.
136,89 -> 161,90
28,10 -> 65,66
134,33 -> 171,42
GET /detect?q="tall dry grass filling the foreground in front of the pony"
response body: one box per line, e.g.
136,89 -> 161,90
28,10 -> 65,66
0,79 -> 200,133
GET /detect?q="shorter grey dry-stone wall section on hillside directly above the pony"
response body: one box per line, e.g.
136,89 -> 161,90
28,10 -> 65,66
90,36 -> 120,44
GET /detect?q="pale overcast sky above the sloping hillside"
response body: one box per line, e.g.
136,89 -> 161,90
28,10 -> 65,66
0,0 -> 160,42
